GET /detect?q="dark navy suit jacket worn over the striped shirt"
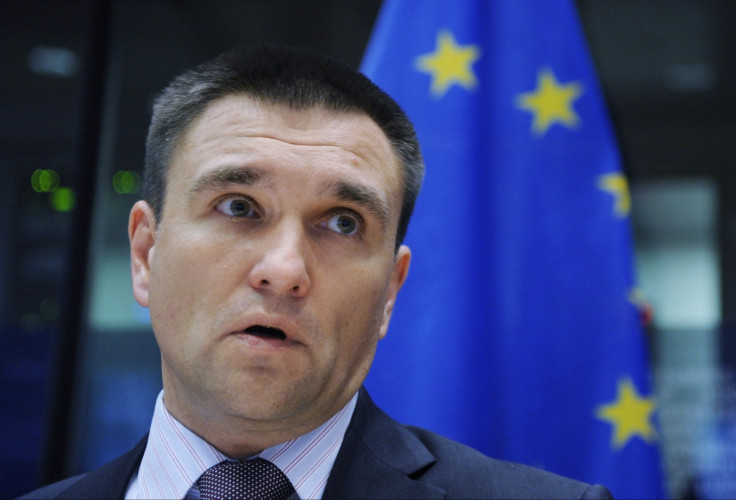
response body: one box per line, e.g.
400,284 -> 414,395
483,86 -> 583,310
21,389 -> 610,500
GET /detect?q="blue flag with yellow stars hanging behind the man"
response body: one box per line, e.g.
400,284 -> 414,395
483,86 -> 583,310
362,0 -> 663,498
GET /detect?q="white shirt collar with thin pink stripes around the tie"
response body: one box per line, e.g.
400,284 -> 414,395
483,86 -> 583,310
125,391 -> 358,499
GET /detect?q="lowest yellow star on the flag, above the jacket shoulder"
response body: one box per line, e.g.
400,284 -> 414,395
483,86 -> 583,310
596,378 -> 656,448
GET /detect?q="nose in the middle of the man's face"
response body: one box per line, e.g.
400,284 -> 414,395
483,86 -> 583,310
248,219 -> 311,298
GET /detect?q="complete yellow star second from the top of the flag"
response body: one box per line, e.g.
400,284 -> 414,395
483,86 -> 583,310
516,68 -> 583,135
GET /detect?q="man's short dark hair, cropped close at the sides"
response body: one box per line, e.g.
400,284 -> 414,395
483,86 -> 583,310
143,45 -> 424,249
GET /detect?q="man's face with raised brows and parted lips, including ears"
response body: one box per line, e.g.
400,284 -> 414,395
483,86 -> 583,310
129,96 -> 410,454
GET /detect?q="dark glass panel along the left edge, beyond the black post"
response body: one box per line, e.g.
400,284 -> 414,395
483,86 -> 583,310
0,0 -> 86,497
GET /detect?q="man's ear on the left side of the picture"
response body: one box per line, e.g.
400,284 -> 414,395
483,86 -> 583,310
128,201 -> 156,307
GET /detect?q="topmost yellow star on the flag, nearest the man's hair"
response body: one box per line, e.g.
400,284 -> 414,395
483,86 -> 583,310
414,30 -> 480,97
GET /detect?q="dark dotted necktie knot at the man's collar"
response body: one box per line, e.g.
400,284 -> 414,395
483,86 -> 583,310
197,458 -> 294,500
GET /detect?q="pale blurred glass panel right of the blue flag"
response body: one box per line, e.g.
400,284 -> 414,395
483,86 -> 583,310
633,178 -> 723,498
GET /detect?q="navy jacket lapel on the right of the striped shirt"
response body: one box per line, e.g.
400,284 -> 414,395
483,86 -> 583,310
323,389 -> 446,498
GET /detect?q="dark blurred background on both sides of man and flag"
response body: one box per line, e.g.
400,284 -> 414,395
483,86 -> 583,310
0,0 -> 736,498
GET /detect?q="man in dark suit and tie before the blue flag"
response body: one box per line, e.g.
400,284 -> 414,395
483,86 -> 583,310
20,47 -> 608,499
